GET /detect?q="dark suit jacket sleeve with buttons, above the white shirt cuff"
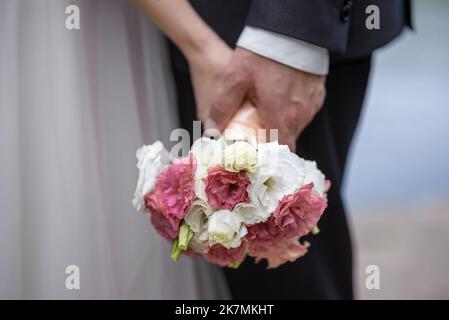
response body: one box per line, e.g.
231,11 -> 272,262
242,0 -> 410,55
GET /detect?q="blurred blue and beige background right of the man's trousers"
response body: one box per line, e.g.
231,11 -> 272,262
344,0 -> 449,299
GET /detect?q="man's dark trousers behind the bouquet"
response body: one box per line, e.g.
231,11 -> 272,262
174,56 -> 371,299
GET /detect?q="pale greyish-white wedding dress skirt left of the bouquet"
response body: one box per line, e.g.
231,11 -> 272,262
0,0 -> 228,299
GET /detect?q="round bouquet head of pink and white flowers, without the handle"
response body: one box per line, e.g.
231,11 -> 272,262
133,104 -> 329,268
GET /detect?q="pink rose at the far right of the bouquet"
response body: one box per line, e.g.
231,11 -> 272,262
273,183 -> 327,238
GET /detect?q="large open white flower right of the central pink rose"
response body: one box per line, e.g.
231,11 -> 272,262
235,142 -> 304,224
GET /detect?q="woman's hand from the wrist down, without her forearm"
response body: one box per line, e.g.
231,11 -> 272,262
187,37 -> 233,121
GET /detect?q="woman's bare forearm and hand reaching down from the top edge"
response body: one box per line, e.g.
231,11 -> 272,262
131,0 -> 233,120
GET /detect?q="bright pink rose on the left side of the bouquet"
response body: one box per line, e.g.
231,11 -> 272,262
155,154 -> 196,220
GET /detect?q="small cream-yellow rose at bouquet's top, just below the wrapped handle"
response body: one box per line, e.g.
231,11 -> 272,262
224,141 -> 257,172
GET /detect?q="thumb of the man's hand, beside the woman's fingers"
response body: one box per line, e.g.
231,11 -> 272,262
204,75 -> 248,131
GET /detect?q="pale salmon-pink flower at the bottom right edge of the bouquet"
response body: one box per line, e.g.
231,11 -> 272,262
248,236 -> 309,269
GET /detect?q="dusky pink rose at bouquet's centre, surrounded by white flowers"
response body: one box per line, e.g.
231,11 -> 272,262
204,167 -> 250,211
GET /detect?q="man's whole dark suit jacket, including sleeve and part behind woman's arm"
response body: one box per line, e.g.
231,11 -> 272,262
173,0 -> 411,68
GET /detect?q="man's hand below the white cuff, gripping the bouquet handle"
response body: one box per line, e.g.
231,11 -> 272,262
205,48 -> 326,150
